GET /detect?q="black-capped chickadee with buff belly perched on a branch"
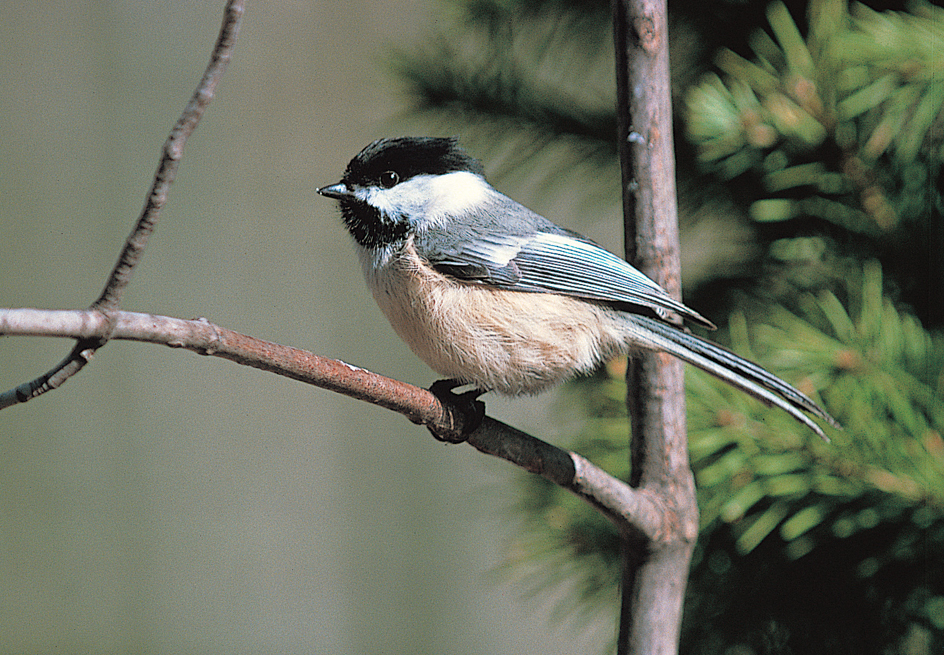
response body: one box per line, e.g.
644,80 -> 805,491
318,137 -> 837,438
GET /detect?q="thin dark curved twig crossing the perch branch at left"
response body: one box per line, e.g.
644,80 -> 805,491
0,0 -> 244,409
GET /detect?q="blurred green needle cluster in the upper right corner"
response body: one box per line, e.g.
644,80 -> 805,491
687,0 -> 944,236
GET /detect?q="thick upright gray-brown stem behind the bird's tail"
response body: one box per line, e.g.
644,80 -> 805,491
612,0 -> 698,655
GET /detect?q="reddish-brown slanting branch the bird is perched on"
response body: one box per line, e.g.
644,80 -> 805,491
0,309 -> 668,540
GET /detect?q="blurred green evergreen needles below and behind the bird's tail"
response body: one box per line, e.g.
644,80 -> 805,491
515,263 -> 944,653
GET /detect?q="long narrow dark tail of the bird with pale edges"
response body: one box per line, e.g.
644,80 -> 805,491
627,314 -> 840,441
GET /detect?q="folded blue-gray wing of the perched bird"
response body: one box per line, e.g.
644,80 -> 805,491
418,223 -> 714,328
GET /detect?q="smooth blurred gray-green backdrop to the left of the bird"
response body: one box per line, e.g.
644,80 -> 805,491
0,0 -> 619,655
